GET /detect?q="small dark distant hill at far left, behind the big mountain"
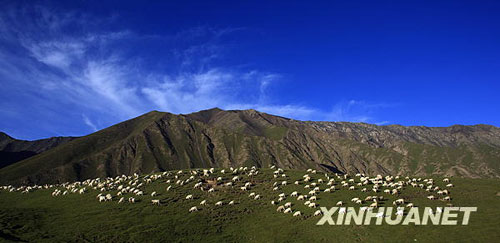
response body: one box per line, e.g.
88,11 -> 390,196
0,132 -> 75,168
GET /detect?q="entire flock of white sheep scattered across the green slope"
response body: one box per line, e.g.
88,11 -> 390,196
0,166 -> 453,217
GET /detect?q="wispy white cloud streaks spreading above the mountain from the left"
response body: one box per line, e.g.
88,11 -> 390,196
0,3 -> 392,139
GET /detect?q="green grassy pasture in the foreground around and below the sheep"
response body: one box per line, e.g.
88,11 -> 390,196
0,169 -> 500,242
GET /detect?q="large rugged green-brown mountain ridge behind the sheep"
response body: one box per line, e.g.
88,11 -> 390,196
0,109 -> 500,184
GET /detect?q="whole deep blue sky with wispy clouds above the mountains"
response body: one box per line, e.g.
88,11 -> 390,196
0,1 -> 500,139
